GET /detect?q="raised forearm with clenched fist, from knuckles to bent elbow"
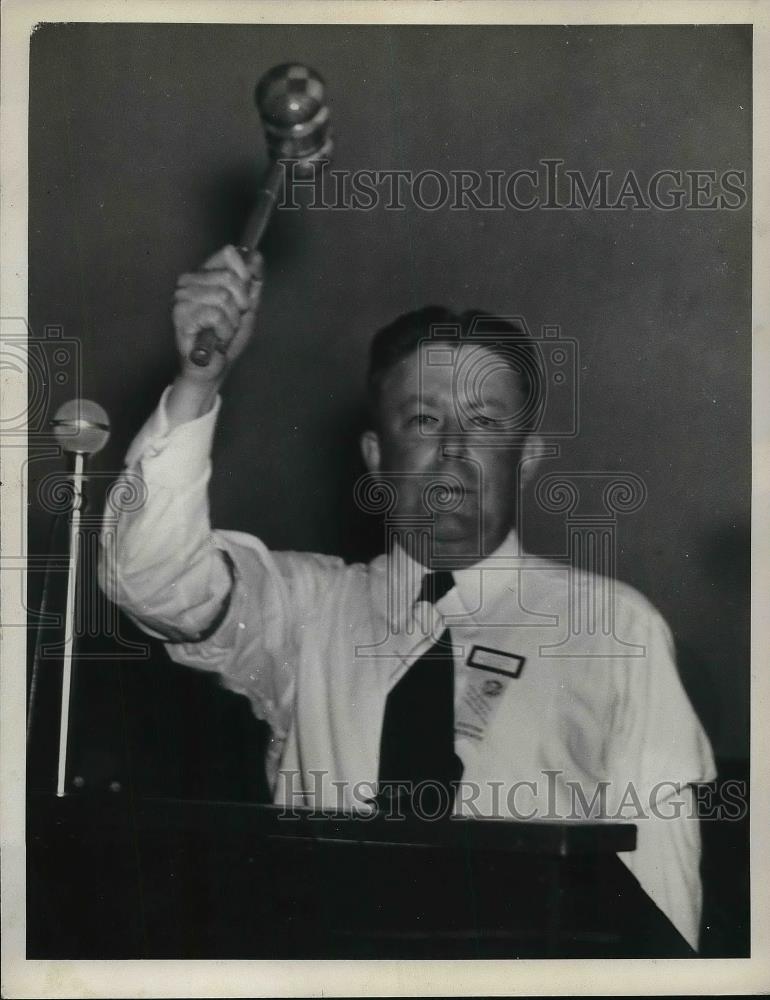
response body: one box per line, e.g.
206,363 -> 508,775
100,246 -> 262,642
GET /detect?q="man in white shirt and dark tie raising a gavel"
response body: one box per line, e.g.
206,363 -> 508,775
101,247 -> 715,947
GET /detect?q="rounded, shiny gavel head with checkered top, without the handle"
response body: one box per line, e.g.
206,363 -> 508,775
255,63 -> 332,164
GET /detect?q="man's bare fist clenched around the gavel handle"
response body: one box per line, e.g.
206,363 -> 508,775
173,246 -> 263,382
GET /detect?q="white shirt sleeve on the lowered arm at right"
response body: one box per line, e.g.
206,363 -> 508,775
610,605 -> 716,950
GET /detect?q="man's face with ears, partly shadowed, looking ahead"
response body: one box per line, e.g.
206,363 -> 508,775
362,342 -> 533,568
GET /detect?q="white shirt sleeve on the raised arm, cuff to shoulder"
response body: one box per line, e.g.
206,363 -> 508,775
99,390 -> 344,740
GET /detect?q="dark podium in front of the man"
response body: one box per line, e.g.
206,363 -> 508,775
27,794 -> 694,959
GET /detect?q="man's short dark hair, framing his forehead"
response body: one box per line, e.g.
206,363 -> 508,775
366,306 -> 545,433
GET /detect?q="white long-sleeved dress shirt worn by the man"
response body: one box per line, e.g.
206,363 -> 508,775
100,386 -> 716,947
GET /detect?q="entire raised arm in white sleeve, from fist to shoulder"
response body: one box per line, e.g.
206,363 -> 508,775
100,247 -> 344,756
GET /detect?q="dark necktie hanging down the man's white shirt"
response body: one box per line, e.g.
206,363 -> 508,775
378,571 -> 463,815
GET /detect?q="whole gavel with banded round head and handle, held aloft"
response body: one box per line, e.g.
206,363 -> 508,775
190,63 -> 332,368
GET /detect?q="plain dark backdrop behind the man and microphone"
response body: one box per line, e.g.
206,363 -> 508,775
29,24 -> 751,947
